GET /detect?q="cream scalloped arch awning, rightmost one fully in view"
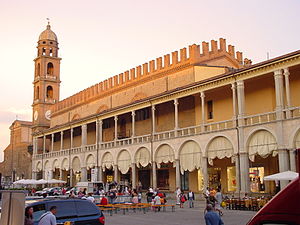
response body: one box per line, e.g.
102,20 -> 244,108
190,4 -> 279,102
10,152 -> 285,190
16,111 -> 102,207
248,130 -> 277,162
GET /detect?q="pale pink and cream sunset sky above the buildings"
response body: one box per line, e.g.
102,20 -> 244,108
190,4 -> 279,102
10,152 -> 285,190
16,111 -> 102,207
0,0 -> 300,161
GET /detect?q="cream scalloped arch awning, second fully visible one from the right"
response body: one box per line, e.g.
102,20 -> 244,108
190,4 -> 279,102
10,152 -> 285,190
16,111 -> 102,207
207,137 -> 234,165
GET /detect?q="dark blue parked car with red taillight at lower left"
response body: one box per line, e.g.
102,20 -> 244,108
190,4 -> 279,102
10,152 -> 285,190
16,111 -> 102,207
28,199 -> 105,225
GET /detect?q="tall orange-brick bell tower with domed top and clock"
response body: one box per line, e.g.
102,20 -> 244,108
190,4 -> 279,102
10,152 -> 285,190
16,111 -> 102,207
32,22 -> 61,132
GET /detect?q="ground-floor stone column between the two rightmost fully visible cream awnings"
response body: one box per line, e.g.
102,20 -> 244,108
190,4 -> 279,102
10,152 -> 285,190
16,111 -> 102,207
240,152 -> 250,194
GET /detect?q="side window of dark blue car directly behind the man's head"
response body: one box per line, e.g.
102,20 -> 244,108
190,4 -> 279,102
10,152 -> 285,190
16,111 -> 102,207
47,200 -> 77,219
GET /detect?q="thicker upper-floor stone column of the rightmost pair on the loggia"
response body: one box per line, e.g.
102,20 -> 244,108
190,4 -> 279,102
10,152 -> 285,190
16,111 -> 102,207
274,69 -> 284,120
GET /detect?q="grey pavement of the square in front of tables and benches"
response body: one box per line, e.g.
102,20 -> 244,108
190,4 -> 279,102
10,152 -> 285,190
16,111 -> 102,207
104,201 -> 256,225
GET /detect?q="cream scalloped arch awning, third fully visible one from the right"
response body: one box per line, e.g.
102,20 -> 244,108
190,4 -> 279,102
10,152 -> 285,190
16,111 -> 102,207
179,141 -> 202,174
